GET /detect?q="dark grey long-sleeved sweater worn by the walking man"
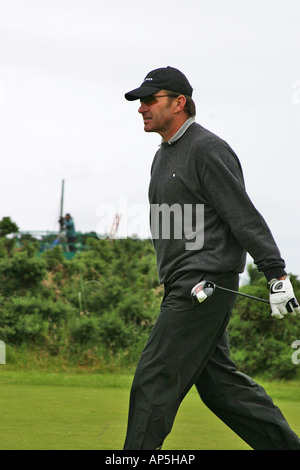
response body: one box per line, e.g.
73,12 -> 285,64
149,123 -> 286,283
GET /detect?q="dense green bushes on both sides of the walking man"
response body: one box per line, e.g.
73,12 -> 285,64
0,228 -> 300,378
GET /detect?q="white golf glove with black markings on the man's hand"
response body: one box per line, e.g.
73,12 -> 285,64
269,276 -> 300,319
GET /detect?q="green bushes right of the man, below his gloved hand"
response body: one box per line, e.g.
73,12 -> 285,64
228,267 -> 300,379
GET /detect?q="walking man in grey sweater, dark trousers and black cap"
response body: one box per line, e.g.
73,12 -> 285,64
124,67 -> 300,450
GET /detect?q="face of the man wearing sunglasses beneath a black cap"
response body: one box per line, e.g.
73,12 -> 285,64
138,90 -> 175,135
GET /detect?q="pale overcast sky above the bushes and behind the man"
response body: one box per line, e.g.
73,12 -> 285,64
0,0 -> 300,275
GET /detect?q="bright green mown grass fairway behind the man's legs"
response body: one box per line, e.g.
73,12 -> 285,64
0,367 -> 300,450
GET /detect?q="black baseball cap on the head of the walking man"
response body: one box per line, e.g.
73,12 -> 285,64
125,67 -> 193,101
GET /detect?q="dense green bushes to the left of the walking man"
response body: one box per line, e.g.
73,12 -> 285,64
0,235 -> 160,368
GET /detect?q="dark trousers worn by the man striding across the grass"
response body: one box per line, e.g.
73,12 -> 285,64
124,273 -> 300,450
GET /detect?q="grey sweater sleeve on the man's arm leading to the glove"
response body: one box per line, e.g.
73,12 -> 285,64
199,140 -> 286,281
